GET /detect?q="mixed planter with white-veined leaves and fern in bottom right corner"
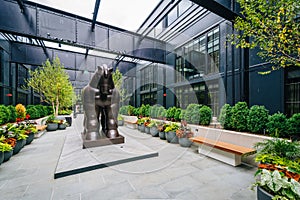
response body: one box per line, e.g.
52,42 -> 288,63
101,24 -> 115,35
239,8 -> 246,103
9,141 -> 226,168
253,138 -> 300,200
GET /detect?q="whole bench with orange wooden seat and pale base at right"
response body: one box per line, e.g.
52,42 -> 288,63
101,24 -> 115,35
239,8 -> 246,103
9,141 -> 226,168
190,136 -> 255,166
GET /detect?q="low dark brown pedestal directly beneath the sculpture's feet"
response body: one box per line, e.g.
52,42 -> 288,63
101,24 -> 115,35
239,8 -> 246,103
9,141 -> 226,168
81,133 -> 124,149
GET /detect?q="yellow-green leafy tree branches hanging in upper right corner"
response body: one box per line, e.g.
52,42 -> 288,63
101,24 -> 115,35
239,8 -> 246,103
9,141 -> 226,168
230,0 -> 300,73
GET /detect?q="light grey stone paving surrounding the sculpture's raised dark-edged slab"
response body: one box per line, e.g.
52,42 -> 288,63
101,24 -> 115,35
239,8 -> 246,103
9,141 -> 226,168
0,116 -> 256,200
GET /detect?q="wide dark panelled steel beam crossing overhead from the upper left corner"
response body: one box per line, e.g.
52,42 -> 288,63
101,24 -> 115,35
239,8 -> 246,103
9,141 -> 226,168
0,0 -> 166,63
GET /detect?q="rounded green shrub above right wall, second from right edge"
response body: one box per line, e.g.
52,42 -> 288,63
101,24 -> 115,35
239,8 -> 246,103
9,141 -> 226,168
267,113 -> 287,137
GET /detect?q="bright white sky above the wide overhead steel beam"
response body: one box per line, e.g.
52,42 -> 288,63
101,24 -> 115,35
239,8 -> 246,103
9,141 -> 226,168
31,0 -> 160,31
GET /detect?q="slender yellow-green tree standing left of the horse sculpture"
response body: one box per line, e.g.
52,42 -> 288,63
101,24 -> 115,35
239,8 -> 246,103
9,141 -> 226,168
26,57 -> 75,115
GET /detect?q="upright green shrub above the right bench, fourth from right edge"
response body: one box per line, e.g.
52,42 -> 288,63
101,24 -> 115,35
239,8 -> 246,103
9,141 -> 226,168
232,102 -> 249,131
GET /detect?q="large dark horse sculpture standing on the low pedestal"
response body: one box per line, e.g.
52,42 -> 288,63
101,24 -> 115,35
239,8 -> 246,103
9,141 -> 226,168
82,65 -> 120,146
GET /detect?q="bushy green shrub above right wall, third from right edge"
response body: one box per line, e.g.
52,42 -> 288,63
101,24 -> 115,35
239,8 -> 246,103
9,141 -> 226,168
248,105 -> 269,133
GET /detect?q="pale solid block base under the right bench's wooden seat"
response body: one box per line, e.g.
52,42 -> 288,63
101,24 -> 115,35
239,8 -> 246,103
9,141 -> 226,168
198,144 -> 242,166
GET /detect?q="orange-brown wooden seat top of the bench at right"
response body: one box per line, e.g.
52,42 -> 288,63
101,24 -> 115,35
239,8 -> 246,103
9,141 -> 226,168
190,136 -> 255,155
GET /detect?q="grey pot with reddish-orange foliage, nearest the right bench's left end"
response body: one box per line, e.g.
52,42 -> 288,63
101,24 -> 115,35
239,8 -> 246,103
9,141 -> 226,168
176,120 -> 194,147
